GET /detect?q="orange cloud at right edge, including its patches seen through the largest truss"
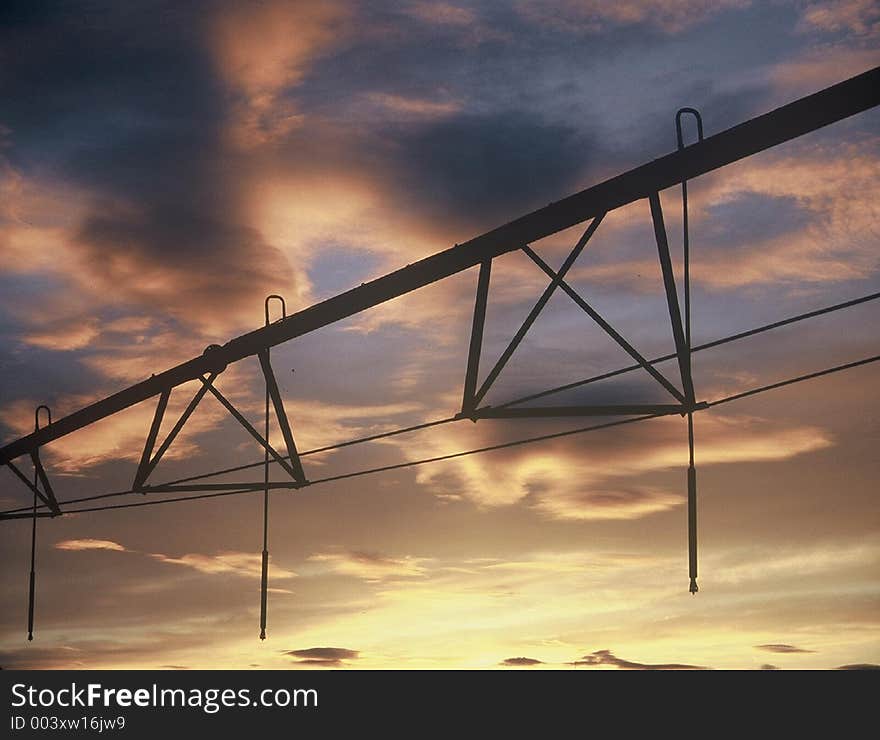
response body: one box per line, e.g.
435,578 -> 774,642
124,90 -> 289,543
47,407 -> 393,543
571,136 -> 880,291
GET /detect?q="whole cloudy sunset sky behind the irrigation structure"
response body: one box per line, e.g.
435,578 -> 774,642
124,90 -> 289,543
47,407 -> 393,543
0,0 -> 880,670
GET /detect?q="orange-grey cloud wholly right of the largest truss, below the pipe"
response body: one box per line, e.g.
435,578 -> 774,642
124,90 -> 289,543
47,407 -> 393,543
692,136 -> 880,289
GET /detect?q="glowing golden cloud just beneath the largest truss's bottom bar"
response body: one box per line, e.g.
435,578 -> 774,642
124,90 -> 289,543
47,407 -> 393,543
406,415 -> 832,521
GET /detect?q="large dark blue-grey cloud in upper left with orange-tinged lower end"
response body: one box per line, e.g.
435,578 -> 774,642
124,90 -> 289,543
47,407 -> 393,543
0,2 -> 293,324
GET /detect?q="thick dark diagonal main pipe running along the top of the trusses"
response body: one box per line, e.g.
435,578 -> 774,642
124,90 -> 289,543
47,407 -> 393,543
0,67 -> 880,465
